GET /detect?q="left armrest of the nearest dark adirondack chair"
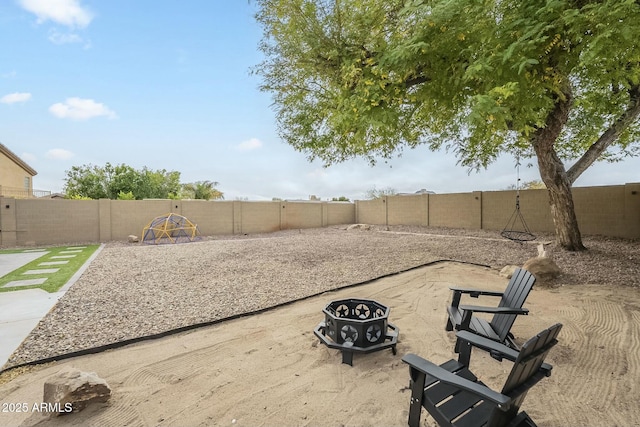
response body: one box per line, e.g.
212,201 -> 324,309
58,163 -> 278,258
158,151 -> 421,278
402,354 -> 511,410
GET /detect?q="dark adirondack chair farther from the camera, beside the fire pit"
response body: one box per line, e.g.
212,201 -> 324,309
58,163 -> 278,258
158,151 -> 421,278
446,268 -> 536,352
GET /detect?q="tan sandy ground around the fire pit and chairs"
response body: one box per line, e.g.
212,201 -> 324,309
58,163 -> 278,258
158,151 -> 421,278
0,262 -> 640,426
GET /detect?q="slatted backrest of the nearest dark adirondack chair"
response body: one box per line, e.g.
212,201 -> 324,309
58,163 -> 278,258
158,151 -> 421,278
487,323 -> 562,425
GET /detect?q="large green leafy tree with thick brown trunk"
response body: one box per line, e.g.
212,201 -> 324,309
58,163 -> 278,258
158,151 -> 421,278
255,0 -> 640,250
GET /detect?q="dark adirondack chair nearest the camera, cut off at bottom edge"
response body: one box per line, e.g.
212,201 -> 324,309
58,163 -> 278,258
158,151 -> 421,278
402,323 -> 562,427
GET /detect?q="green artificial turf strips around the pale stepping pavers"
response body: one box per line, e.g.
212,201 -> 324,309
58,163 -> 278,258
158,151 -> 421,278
0,245 -> 100,292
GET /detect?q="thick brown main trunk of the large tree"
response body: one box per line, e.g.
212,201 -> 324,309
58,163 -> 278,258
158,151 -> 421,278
532,93 -> 586,251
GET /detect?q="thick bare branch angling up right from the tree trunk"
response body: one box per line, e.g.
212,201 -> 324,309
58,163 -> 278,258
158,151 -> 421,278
567,86 -> 640,184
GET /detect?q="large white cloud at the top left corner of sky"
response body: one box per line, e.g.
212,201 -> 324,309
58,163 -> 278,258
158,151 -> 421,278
19,0 -> 93,28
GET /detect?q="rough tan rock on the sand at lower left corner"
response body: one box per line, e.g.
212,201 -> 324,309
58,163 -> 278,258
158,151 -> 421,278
42,367 -> 111,415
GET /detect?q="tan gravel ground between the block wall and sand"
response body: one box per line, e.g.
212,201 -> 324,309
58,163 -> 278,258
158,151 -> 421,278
5,226 -> 640,368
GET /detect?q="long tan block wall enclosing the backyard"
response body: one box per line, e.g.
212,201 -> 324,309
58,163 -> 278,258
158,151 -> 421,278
0,183 -> 640,247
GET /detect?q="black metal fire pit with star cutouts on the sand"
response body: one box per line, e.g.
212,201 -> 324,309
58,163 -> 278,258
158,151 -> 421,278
313,298 -> 399,366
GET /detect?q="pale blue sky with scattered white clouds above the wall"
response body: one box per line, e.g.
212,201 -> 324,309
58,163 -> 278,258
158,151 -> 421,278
0,0 -> 640,200
